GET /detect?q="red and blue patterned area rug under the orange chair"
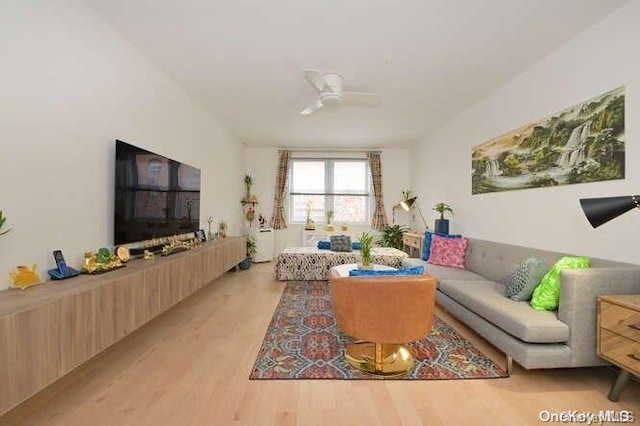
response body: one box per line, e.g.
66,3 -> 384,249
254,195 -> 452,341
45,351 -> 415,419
250,281 -> 508,380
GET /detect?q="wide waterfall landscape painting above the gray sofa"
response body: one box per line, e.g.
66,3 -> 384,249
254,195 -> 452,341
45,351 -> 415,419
471,87 -> 625,194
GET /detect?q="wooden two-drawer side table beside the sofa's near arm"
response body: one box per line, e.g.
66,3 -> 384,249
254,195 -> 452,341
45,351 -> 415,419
598,294 -> 640,402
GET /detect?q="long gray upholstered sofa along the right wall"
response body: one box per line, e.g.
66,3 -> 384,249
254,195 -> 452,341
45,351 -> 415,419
405,239 -> 640,370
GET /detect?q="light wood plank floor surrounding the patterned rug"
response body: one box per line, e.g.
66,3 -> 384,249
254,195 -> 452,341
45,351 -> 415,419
0,263 -> 640,426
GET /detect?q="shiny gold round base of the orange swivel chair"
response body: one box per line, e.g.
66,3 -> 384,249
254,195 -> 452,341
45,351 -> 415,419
345,341 -> 414,377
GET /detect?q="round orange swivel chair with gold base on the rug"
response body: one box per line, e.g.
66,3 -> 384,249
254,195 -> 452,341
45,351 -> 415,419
329,270 -> 436,376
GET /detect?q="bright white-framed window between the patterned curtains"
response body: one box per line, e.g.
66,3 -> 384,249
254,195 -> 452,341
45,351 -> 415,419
289,159 -> 371,224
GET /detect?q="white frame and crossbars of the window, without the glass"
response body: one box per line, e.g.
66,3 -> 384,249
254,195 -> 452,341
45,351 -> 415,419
287,157 -> 373,226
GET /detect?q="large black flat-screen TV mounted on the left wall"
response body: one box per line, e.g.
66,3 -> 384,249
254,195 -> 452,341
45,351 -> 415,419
113,140 -> 200,245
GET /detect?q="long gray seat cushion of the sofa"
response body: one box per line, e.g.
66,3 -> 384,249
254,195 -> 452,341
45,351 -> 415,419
438,279 -> 569,343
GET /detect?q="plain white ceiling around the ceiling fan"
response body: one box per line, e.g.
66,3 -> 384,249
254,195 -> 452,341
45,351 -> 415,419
86,0 -> 626,148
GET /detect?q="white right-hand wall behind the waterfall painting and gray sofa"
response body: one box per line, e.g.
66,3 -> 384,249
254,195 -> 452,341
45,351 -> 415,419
412,2 -> 640,263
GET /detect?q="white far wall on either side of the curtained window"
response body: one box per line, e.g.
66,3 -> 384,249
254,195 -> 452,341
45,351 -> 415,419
238,147 -> 410,254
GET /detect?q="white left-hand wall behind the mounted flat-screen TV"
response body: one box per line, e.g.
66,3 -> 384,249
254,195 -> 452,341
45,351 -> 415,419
0,0 -> 244,289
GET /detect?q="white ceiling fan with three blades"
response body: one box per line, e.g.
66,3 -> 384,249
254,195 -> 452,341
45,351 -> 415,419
300,70 -> 382,115
